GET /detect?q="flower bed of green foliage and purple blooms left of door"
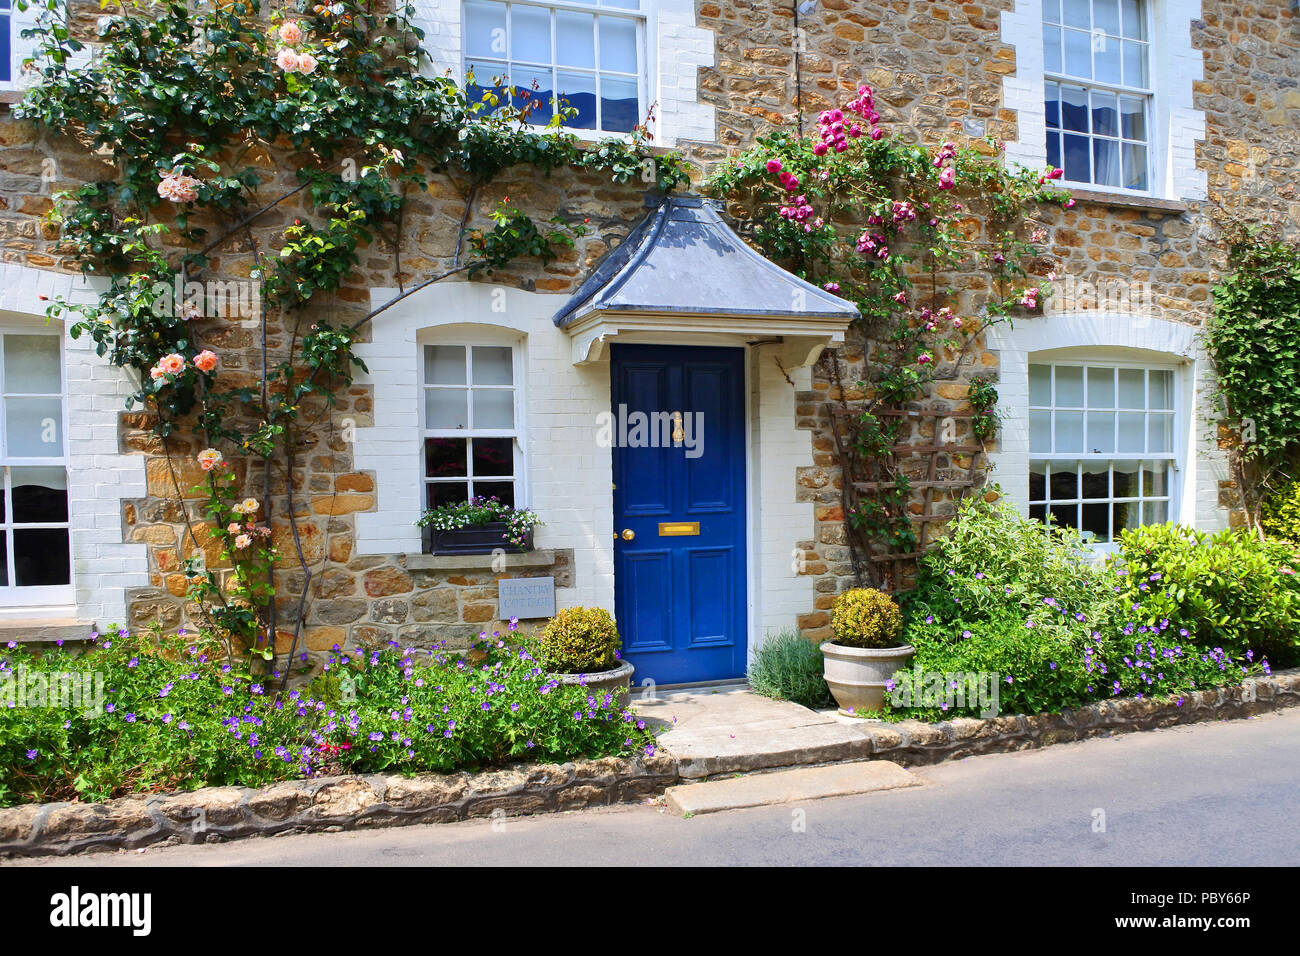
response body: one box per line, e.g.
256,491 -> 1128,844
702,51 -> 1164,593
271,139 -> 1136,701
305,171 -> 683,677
0,631 -> 655,805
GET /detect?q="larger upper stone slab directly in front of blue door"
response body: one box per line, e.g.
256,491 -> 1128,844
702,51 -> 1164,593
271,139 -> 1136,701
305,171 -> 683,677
647,684 -> 872,779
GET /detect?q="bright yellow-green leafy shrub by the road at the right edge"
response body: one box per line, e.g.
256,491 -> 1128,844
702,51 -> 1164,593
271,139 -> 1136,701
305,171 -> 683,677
1114,524 -> 1300,666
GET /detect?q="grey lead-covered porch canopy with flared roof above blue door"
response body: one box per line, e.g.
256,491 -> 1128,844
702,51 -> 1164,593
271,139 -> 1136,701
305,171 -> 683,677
555,195 -> 858,368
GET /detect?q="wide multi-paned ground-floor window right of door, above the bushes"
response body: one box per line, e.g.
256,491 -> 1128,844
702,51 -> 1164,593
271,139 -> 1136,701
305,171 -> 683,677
1030,363 -> 1178,544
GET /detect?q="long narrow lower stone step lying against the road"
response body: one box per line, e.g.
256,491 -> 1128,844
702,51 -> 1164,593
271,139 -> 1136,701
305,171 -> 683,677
666,760 -> 920,816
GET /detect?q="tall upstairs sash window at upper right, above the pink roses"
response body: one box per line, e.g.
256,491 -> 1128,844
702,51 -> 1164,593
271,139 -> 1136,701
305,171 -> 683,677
1043,0 -> 1152,193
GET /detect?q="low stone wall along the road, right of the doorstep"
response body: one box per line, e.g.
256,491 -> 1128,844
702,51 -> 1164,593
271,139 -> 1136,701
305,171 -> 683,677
863,669 -> 1300,766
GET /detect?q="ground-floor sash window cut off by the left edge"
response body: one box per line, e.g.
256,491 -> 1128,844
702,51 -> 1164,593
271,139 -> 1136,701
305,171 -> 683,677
0,333 -> 72,605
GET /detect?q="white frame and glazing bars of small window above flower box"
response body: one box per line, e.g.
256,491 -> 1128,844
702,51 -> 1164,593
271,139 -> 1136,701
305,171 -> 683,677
416,329 -> 528,514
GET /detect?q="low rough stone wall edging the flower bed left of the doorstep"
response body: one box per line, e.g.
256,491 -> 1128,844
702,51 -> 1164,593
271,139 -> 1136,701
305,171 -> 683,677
0,756 -> 677,857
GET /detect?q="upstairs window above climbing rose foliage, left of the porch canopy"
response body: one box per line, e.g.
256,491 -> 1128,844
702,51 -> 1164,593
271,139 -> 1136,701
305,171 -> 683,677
464,0 -> 646,133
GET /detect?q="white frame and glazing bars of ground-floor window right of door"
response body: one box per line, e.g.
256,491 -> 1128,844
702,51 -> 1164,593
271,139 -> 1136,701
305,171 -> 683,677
1026,354 -> 1186,553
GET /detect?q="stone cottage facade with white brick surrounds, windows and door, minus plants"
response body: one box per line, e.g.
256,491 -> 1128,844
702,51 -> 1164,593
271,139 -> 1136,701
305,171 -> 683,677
0,0 -> 1300,683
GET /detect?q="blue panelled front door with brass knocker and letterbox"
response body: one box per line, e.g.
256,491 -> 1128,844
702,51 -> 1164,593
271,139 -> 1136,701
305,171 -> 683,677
611,345 -> 746,684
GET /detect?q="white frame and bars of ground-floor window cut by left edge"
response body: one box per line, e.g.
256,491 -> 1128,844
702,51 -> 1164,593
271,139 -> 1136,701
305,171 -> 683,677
0,325 -> 75,609
